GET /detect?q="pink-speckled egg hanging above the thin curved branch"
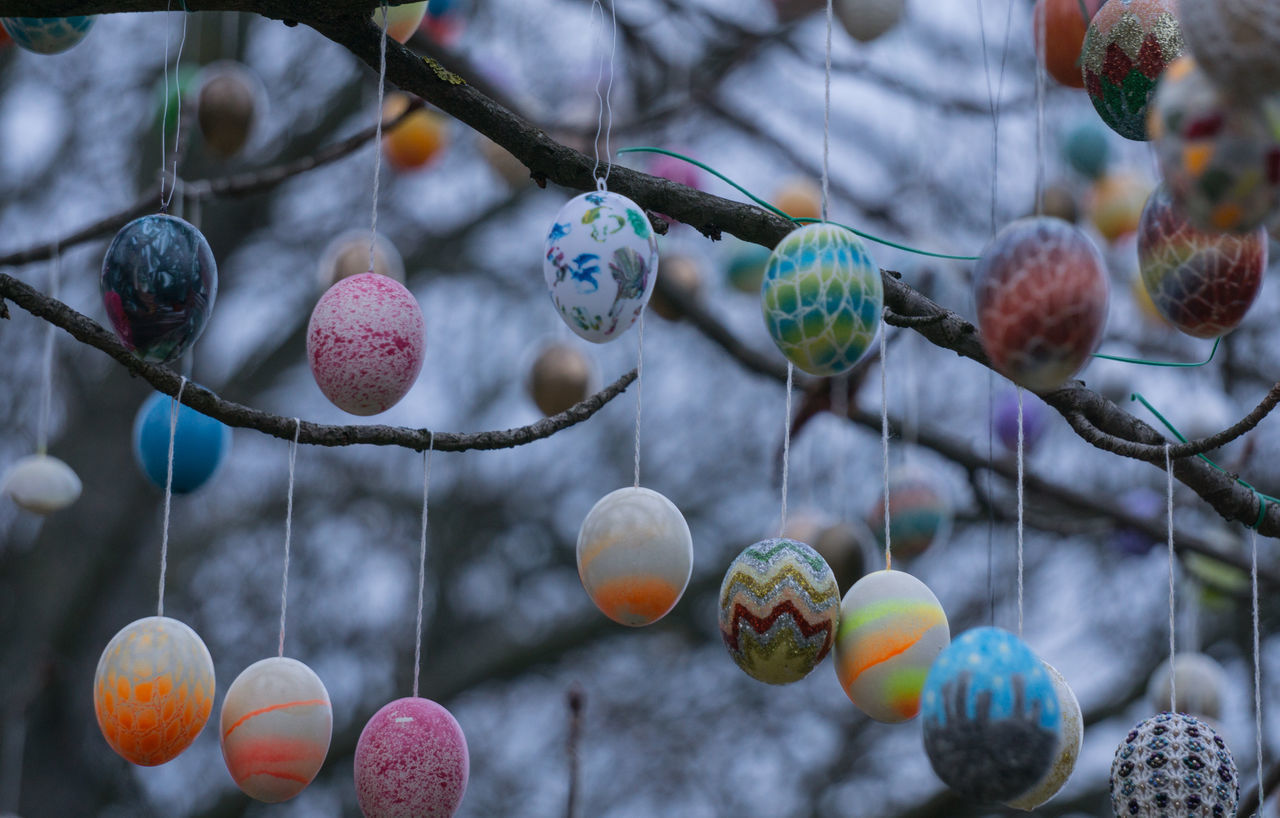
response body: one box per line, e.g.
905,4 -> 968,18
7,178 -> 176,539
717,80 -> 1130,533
307,273 -> 426,415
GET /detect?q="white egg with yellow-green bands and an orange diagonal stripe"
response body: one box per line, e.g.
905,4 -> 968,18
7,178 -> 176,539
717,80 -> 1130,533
836,571 -> 951,723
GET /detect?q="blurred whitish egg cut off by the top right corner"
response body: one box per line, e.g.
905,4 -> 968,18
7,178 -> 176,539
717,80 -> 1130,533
1179,0 -> 1280,99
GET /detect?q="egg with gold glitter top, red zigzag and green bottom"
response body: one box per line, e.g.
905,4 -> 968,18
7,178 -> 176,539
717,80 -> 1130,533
1082,0 -> 1183,141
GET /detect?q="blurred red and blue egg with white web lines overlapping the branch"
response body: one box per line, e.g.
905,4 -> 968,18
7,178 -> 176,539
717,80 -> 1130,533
974,218 -> 1110,392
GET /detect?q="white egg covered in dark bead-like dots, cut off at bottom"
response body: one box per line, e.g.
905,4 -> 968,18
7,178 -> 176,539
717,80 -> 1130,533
1111,713 -> 1240,818
